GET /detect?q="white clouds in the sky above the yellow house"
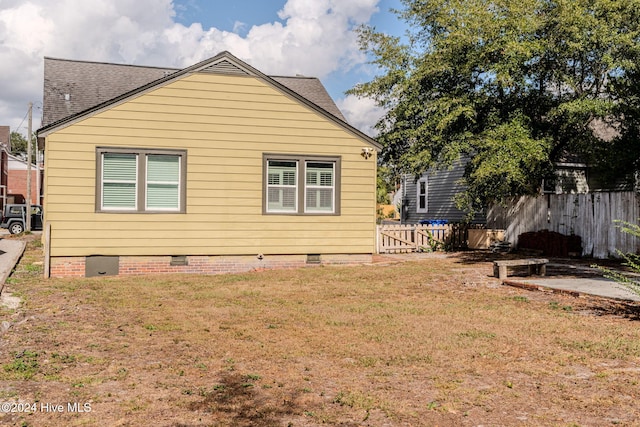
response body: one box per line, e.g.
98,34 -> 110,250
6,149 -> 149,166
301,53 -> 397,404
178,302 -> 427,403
0,0 -> 379,134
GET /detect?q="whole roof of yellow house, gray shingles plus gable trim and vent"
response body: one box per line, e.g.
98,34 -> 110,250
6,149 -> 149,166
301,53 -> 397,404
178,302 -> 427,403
38,52 -> 381,149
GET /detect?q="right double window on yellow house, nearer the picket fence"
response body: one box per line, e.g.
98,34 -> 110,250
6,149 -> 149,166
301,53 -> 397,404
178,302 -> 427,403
263,155 -> 340,215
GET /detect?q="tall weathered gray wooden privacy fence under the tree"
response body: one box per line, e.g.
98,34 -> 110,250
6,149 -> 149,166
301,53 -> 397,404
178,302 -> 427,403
487,191 -> 640,258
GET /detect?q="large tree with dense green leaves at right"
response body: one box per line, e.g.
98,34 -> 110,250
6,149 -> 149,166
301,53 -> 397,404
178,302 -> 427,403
350,0 -> 640,217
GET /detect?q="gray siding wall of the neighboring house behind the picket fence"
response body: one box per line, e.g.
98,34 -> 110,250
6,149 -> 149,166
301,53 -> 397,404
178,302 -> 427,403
401,159 -> 484,224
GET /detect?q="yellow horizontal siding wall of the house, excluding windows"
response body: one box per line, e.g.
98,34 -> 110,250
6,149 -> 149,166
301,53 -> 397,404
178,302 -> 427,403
45,73 -> 376,272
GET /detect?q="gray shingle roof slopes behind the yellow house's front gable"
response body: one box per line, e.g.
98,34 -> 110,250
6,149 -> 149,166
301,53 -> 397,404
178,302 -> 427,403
42,57 -> 346,127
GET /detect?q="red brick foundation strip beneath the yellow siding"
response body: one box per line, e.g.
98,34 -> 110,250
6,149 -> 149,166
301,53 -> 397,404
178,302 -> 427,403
50,254 -> 372,277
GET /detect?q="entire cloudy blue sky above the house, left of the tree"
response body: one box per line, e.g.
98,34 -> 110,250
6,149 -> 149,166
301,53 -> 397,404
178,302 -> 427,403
0,0 -> 404,134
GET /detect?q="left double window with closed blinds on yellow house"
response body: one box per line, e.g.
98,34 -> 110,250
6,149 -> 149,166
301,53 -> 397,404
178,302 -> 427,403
96,148 -> 186,212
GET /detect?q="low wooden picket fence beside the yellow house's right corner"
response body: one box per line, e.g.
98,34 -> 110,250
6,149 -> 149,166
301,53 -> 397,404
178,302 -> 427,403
378,224 -> 454,254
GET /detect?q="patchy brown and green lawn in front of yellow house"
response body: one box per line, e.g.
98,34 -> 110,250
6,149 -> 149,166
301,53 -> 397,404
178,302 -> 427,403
0,242 -> 640,427
